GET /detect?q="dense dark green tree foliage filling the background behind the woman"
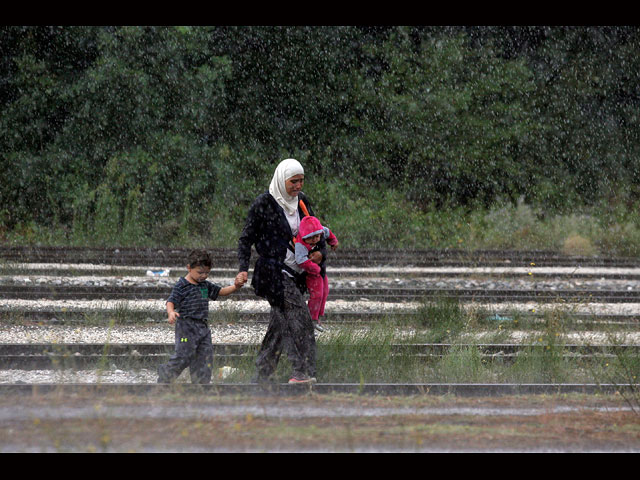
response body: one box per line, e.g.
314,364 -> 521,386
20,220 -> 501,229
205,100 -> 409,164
0,26 -> 640,248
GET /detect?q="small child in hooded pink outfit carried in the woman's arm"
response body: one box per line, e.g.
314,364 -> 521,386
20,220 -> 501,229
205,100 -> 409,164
295,216 -> 338,331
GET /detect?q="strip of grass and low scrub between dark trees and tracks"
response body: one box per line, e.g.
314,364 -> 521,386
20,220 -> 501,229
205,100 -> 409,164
0,192 -> 640,257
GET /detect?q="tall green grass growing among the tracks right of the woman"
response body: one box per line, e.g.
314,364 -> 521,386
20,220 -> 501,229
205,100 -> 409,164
206,300 -> 640,404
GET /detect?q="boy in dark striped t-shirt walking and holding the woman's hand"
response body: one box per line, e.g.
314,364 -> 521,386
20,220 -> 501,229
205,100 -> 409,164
158,250 -> 244,384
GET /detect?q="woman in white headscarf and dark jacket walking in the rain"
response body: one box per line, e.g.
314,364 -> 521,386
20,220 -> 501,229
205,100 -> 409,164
237,158 -> 326,383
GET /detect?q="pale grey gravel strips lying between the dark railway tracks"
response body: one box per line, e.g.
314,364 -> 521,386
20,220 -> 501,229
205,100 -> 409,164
0,264 -> 640,383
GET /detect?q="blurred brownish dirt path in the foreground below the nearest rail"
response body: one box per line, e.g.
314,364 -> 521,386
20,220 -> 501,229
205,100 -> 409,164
0,395 -> 640,453
